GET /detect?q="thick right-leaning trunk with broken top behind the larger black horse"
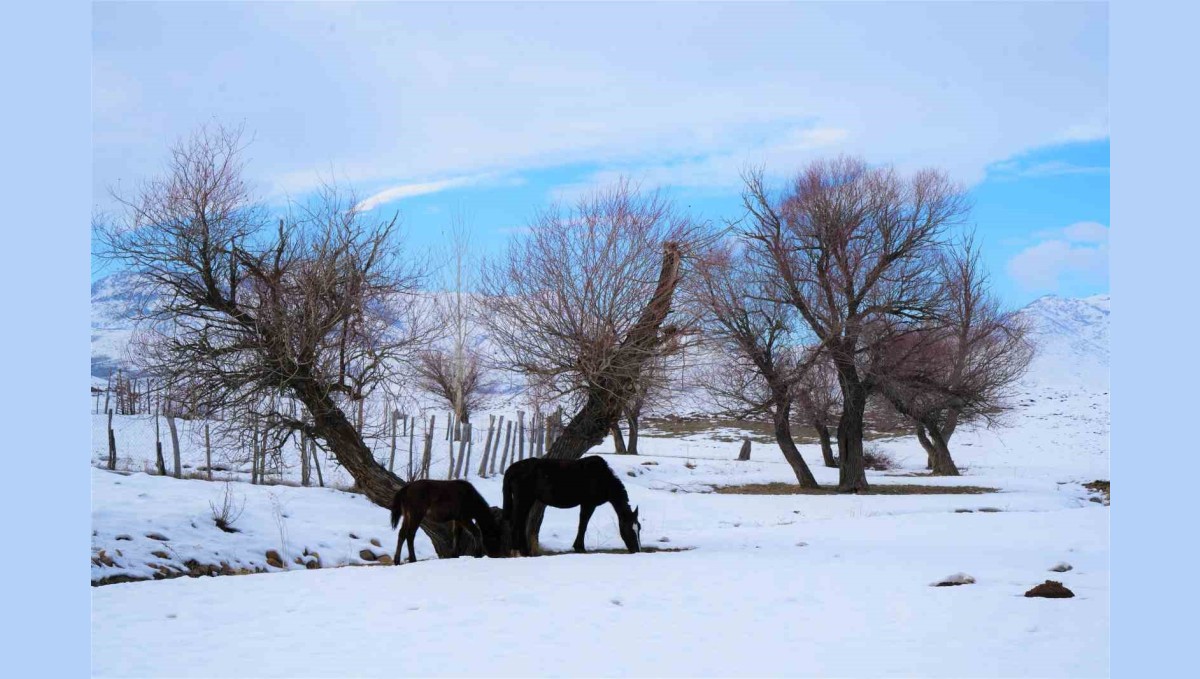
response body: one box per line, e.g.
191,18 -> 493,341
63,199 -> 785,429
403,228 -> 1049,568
526,242 -> 680,554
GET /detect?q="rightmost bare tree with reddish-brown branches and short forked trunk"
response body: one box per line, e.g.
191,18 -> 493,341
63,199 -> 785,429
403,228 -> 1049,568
875,236 -> 1033,476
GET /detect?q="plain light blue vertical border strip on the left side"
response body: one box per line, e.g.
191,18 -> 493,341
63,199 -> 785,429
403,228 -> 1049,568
0,1 -> 91,677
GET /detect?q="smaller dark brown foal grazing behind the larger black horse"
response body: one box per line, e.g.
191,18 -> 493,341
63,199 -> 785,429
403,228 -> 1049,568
391,479 -> 503,565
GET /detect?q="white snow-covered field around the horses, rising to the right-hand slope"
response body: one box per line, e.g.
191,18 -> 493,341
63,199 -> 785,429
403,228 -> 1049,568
92,299 -> 1109,677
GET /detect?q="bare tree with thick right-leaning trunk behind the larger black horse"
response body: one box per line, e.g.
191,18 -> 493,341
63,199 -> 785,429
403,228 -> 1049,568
481,181 -> 697,554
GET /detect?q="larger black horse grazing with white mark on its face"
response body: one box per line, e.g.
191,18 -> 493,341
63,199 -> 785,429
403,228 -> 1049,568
503,455 -> 642,557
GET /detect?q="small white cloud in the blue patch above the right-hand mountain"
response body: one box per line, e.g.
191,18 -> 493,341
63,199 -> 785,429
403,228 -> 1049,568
1008,222 -> 1109,292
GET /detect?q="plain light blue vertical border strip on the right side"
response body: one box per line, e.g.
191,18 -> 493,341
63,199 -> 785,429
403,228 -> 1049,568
1109,0 -> 1200,677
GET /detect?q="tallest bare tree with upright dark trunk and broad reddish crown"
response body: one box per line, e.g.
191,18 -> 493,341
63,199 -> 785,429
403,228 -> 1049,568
743,158 -> 968,492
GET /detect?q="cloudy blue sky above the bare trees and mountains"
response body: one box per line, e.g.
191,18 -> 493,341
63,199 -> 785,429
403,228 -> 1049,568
92,2 -> 1109,304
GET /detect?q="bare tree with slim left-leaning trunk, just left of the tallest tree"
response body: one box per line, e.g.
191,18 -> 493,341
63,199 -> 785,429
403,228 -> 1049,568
688,244 -> 820,488
